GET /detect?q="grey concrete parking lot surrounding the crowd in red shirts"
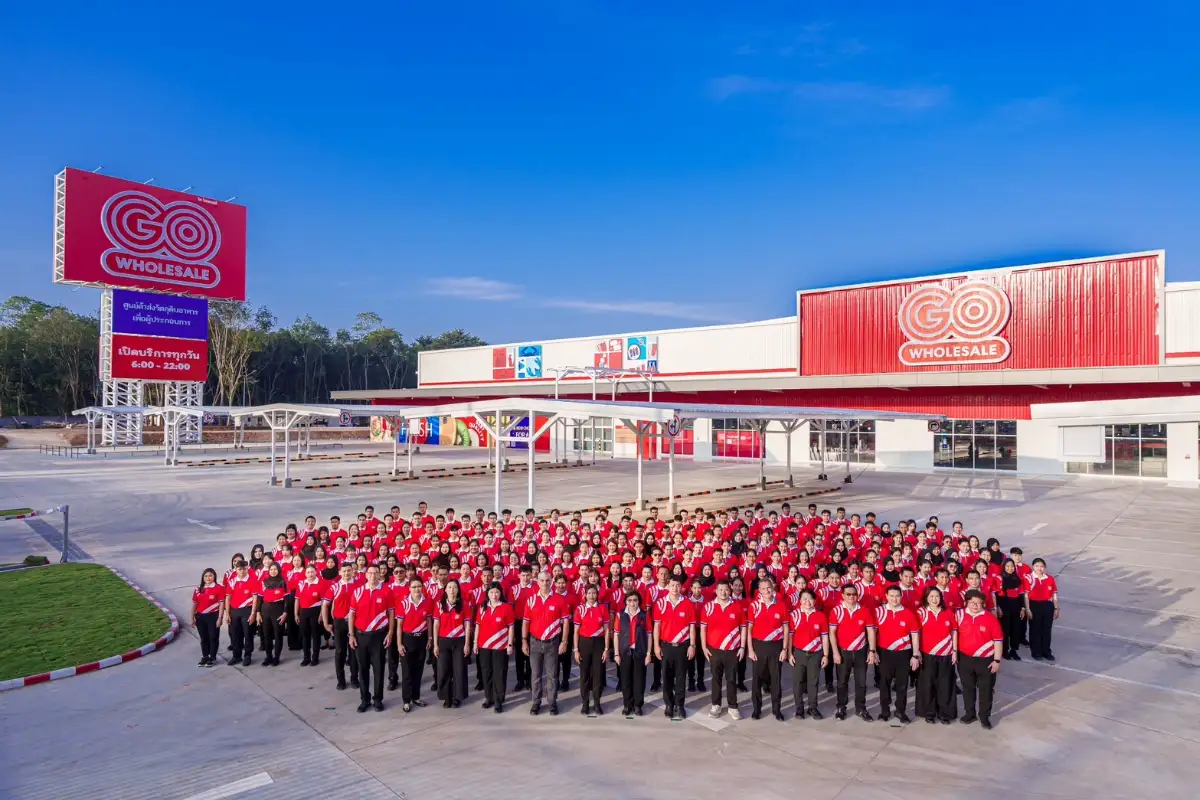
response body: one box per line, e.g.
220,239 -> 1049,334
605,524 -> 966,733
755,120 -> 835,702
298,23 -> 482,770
0,451 -> 1200,800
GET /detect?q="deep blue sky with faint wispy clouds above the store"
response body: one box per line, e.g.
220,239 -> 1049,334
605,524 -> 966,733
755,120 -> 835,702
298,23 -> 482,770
0,0 -> 1200,342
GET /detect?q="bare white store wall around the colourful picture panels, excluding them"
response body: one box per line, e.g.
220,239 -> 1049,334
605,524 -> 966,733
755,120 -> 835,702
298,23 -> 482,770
418,318 -> 798,386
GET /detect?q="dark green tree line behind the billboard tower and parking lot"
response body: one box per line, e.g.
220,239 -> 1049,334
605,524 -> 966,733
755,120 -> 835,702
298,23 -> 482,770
0,296 -> 486,416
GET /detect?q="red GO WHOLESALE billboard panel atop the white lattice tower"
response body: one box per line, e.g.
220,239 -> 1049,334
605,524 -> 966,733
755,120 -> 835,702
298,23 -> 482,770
54,169 -> 246,300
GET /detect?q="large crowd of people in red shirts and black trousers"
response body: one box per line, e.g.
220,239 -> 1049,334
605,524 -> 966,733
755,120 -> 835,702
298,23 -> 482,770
192,503 -> 1058,729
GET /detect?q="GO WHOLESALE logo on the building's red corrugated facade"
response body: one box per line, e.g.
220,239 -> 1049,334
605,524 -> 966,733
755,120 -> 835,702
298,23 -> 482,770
899,281 -> 1013,367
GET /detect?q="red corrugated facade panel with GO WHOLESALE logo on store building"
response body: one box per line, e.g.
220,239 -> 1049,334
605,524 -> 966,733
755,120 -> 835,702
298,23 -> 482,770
798,252 -> 1164,375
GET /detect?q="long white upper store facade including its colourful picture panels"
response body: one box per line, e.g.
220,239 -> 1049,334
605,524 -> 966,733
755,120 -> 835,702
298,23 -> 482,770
418,317 -> 798,389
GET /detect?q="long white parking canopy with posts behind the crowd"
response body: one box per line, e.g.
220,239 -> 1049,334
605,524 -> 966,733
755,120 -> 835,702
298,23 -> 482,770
74,397 -> 946,512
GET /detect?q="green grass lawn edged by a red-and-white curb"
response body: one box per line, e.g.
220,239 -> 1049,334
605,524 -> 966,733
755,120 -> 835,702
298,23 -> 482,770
0,564 -> 170,680
